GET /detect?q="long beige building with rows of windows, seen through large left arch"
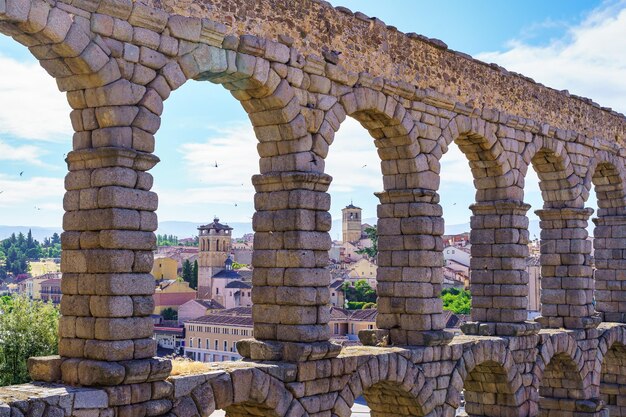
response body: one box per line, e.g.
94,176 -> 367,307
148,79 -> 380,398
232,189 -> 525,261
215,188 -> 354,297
185,307 -> 253,362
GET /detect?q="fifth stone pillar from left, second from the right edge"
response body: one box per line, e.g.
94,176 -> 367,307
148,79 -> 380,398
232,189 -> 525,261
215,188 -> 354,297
535,208 -> 600,329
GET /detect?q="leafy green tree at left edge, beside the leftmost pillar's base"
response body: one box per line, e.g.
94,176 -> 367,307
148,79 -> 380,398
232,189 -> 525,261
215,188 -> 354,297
0,296 -> 59,385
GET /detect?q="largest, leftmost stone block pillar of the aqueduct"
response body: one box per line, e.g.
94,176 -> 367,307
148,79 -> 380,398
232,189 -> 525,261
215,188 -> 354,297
59,145 -> 171,386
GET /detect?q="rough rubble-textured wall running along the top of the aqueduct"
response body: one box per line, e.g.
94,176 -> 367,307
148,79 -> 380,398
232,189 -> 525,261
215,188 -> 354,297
144,0 -> 626,144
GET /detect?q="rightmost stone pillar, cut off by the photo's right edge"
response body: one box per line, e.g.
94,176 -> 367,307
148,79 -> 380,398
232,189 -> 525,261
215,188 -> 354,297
593,213 -> 626,323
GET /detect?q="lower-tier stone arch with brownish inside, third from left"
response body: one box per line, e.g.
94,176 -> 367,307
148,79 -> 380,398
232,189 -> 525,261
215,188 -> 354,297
446,340 -> 529,417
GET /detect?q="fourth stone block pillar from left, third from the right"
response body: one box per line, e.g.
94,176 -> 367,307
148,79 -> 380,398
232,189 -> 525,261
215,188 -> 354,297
462,200 -> 539,336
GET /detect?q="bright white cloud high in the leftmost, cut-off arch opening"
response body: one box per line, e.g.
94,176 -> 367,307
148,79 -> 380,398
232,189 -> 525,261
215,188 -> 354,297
0,55 -> 73,142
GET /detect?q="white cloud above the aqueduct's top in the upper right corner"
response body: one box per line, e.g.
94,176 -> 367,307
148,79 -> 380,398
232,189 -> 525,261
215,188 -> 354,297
476,0 -> 626,112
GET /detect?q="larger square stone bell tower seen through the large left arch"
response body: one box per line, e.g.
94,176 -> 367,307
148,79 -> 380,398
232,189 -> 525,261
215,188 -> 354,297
198,217 -> 233,299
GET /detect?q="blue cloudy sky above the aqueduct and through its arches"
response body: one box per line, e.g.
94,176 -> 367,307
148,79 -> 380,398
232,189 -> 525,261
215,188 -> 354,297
0,0 -> 626,238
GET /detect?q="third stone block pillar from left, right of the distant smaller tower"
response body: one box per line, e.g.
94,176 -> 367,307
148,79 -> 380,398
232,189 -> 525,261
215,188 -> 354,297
368,190 -> 452,345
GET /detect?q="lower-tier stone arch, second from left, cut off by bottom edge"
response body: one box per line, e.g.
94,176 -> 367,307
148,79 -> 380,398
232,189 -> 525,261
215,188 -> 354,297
332,353 -> 440,417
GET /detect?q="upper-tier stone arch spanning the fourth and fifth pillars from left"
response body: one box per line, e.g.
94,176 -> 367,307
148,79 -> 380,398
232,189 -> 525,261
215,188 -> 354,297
522,135 -> 584,208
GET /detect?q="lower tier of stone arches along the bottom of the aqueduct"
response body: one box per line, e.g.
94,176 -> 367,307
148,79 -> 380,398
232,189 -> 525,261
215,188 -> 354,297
7,324 -> 626,417
